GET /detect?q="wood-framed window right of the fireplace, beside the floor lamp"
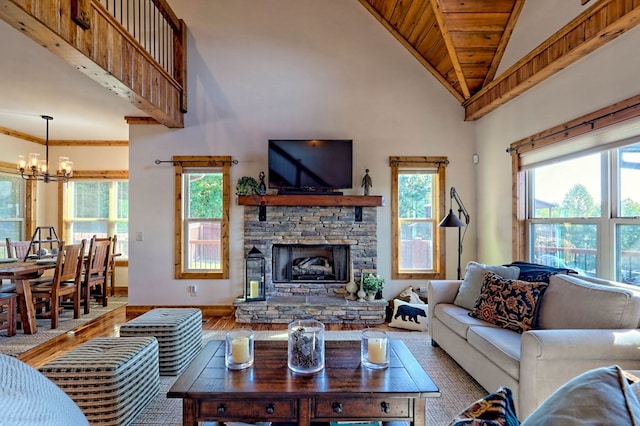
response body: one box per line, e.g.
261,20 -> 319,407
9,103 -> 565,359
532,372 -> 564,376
389,157 -> 447,279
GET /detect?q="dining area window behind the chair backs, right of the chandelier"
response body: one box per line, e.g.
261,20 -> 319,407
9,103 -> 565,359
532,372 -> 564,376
60,176 -> 129,261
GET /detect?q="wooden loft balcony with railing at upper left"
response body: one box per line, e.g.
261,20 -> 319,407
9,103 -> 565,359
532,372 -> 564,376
0,0 -> 187,127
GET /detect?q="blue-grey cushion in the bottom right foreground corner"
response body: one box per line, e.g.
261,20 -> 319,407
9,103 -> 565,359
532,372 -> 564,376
522,365 -> 640,426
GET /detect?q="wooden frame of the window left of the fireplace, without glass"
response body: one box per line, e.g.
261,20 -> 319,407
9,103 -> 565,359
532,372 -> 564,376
173,156 -> 232,279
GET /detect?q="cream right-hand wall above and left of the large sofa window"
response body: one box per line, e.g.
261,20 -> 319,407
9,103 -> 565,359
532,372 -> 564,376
476,27 -> 640,263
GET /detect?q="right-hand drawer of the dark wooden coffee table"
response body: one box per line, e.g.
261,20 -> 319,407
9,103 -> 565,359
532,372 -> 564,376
315,398 -> 413,418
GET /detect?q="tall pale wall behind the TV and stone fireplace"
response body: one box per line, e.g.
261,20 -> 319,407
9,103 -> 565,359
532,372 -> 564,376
129,0 -> 477,305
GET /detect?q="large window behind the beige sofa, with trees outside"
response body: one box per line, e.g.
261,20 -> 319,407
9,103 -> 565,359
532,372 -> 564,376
527,143 -> 640,285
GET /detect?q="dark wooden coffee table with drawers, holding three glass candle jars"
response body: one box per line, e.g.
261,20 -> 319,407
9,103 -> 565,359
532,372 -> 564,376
167,340 -> 440,426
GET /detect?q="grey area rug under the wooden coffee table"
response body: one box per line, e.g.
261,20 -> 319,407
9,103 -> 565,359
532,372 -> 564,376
132,330 -> 487,426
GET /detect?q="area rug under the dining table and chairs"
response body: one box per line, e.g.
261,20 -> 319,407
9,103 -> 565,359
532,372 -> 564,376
0,296 -> 129,356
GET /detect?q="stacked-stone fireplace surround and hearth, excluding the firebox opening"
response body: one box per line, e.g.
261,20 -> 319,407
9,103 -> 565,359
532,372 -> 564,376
234,206 -> 387,324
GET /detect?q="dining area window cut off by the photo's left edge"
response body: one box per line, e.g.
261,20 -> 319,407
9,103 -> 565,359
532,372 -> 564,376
0,171 -> 28,258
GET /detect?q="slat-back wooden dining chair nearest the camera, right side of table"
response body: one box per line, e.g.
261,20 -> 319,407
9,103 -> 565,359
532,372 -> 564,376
31,240 -> 86,329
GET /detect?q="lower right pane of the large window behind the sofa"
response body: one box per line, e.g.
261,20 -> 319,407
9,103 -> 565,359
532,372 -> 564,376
616,225 -> 640,285
